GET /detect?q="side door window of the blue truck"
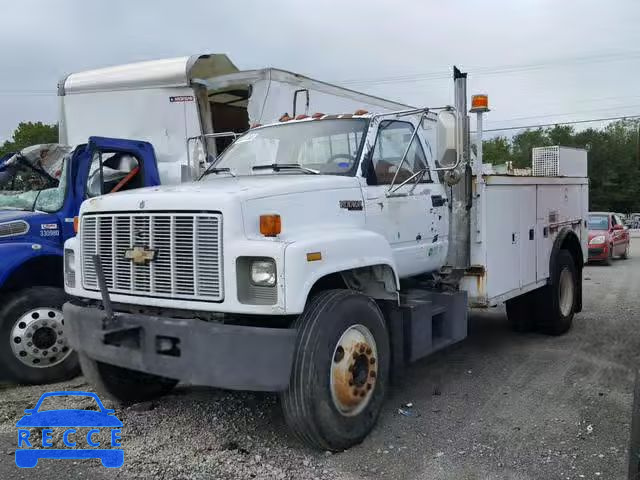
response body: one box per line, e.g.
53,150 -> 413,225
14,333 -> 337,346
86,152 -> 143,198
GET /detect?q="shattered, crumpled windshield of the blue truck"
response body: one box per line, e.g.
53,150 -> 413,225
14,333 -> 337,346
0,145 -> 69,213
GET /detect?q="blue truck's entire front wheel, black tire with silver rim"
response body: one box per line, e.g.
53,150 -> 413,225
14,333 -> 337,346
0,287 -> 80,384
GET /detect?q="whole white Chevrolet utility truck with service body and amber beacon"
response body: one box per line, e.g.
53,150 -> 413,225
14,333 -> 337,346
64,69 -> 588,450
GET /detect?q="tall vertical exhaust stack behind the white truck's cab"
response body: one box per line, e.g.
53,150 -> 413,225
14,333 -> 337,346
447,66 -> 472,270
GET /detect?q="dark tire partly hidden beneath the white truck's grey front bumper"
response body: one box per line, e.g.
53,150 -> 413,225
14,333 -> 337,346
78,353 -> 178,404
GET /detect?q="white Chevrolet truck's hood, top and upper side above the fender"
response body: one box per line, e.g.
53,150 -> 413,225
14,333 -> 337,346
80,173 -> 365,241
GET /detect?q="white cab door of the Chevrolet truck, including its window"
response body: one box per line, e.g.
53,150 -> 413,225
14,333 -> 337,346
363,120 -> 447,277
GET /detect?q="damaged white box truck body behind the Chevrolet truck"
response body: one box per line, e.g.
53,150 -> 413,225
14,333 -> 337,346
58,54 -> 408,185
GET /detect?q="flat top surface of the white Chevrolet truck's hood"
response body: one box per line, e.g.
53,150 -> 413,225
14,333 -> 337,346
81,173 -> 360,214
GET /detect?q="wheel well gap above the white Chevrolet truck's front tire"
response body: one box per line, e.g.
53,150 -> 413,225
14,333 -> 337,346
308,265 -> 398,300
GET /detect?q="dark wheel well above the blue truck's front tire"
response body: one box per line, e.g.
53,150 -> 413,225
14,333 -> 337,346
2,255 -> 64,291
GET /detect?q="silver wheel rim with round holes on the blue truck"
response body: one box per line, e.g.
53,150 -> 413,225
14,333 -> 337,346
9,308 -> 71,368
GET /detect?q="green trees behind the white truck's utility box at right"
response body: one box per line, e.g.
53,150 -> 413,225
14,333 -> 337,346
482,120 -> 640,213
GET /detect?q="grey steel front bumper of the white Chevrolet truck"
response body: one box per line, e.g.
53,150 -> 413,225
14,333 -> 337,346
63,303 -> 297,391
